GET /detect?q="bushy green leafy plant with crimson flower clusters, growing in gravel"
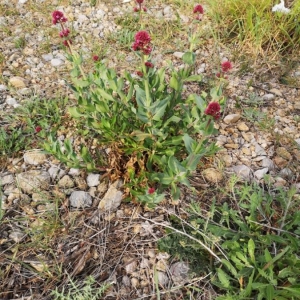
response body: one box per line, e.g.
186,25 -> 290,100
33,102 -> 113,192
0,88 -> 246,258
46,8 -> 223,204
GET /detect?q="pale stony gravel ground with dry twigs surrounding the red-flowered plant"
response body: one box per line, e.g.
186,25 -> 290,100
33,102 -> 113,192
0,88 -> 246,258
0,0 -> 300,299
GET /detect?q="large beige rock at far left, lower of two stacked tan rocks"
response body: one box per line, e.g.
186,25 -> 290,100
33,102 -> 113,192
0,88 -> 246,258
16,170 -> 50,194
